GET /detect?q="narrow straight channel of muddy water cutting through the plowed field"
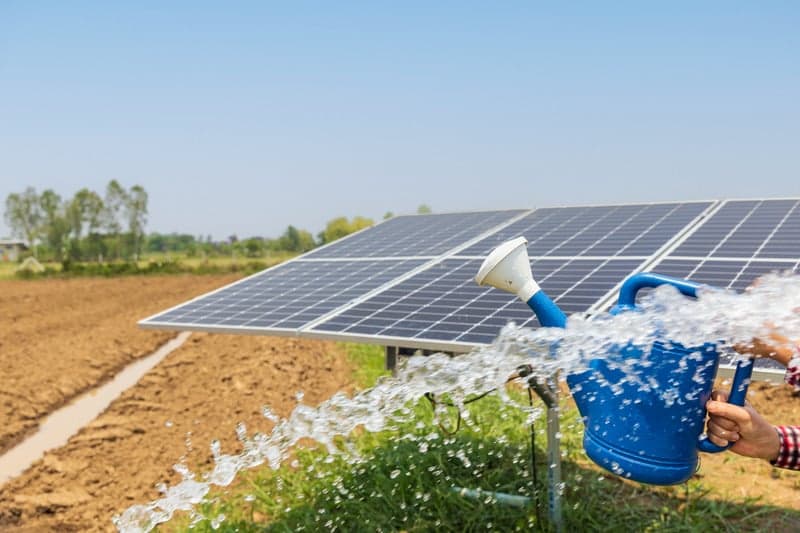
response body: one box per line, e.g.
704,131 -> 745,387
0,332 -> 189,485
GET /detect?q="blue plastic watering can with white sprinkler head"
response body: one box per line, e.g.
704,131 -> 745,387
475,237 -> 753,485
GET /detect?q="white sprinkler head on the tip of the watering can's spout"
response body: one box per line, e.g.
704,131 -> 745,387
475,237 -> 539,302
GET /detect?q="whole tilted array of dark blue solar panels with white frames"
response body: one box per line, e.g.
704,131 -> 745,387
140,199 -> 800,358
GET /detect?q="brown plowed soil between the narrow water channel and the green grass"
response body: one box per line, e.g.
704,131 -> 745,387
0,333 -> 351,531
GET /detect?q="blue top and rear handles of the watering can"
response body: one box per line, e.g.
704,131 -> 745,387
616,272 -> 754,453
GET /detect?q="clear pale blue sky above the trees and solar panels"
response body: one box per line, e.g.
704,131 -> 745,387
0,0 -> 800,238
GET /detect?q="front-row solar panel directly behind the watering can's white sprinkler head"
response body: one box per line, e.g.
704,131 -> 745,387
307,258 -> 641,349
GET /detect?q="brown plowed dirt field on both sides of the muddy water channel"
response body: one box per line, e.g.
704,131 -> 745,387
0,276 -> 351,532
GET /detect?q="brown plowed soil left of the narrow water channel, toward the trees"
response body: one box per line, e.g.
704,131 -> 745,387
0,275 -> 237,453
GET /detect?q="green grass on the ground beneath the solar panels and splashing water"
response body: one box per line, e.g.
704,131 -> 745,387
163,345 -> 800,532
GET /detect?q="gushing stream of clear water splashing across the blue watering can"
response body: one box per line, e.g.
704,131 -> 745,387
113,275 -> 800,532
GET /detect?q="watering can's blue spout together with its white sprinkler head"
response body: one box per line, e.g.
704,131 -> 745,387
475,237 -> 567,328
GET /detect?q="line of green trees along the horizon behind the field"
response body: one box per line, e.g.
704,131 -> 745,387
4,184 -> 431,263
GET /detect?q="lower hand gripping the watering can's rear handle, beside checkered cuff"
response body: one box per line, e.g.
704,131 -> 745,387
706,391 -> 781,461
